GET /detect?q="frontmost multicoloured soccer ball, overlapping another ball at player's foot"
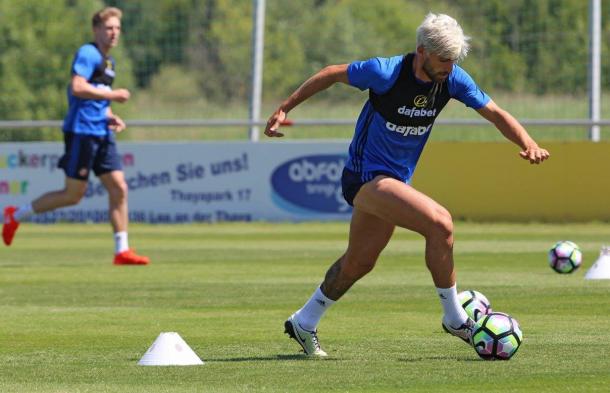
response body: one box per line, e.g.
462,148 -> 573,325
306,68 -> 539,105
472,312 -> 523,360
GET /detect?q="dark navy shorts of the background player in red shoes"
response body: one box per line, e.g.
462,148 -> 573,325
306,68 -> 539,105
57,132 -> 123,181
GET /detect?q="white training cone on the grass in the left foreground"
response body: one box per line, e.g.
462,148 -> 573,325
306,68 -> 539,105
138,332 -> 203,366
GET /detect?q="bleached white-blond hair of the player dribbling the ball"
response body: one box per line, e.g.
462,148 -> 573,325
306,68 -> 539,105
417,13 -> 470,61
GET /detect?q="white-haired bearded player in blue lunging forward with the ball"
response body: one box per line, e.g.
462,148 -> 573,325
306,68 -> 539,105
265,14 -> 549,356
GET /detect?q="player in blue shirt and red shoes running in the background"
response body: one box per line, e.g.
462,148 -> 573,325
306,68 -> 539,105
2,7 -> 149,265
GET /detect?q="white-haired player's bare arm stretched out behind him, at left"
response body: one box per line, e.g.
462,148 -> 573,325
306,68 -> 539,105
265,64 -> 349,137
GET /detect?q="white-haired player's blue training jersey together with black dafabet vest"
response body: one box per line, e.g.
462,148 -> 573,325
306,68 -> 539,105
346,54 -> 490,183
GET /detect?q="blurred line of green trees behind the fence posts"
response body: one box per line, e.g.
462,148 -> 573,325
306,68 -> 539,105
0,0 -> 610,140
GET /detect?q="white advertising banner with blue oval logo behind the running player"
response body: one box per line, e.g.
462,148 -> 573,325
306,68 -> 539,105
0,141 -> 351,223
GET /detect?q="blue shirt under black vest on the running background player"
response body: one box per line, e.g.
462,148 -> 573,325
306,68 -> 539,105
63,44 -> 114,136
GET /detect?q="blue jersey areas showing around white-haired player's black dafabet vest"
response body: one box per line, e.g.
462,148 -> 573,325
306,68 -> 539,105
346,55 -> 490,182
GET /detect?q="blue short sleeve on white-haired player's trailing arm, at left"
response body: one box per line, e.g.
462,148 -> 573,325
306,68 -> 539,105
347,56 -> 404,94
